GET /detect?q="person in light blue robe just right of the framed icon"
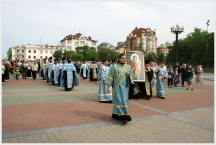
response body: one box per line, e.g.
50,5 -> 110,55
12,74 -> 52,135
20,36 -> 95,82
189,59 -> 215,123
155,62 -> 168,99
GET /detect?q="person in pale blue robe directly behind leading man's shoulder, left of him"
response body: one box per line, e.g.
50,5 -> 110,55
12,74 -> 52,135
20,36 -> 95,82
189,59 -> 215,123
98,59 -> 112,102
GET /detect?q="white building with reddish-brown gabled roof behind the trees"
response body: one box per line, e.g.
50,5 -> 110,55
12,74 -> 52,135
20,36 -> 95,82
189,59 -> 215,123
60,33 -> 98,51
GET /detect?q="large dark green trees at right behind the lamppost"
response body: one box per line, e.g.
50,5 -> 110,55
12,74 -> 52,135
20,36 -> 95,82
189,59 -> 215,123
166,28 -> 214,66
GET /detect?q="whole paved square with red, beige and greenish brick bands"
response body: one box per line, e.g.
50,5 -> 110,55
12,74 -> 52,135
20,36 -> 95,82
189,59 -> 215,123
2,74 -> 214,143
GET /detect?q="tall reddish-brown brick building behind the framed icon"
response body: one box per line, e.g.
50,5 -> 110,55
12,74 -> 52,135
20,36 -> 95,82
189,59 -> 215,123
126,27 -> 157,53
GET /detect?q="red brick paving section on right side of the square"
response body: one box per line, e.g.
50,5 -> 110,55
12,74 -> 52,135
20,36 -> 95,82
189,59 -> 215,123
133,87 -> 214,112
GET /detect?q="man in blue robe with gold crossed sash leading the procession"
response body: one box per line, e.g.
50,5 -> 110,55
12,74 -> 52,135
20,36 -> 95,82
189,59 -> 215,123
105,53 -> 133,125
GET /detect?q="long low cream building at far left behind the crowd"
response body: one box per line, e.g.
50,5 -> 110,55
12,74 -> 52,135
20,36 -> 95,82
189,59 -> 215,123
10,44 -> 64,60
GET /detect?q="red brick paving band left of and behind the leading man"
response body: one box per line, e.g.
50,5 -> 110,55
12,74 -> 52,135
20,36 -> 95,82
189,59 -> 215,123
2,100 -> 158,133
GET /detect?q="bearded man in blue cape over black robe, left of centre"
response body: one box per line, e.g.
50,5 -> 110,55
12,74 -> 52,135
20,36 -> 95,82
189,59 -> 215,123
61,57 -> 79,91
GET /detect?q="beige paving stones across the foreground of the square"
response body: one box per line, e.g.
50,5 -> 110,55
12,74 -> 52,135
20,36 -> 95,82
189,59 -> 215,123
3,108 -> 214,143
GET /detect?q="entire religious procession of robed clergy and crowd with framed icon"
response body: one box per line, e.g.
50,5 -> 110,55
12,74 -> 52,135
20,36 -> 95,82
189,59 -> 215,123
2,51 -> 204,125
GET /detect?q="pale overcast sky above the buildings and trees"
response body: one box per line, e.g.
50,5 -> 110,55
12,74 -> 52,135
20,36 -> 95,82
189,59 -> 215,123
2,0 -> 215,58
